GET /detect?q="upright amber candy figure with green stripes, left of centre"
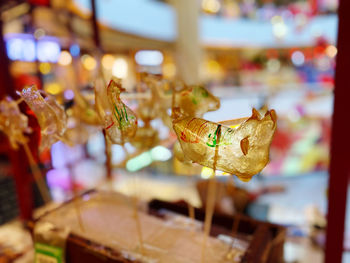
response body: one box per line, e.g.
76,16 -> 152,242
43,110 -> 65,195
96,79 -> 137,144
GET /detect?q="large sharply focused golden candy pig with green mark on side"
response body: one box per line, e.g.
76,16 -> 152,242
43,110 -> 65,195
173,109 -> 277,182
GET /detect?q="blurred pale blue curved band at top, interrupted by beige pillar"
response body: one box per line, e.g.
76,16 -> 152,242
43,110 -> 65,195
74,0 -> 338,48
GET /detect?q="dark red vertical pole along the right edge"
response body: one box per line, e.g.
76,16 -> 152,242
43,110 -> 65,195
325,0 -> 350,263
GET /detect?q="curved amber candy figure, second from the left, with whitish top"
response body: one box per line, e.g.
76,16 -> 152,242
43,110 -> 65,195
20,85 -> 67,150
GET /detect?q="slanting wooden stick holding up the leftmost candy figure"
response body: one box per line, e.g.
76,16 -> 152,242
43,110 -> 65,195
22,143 -> 51,204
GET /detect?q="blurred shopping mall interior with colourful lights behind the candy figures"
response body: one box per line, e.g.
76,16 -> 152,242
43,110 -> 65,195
0,0 -> 350,262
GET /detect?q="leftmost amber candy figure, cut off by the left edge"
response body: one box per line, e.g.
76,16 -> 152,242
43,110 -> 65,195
0,97 -> 31,149
